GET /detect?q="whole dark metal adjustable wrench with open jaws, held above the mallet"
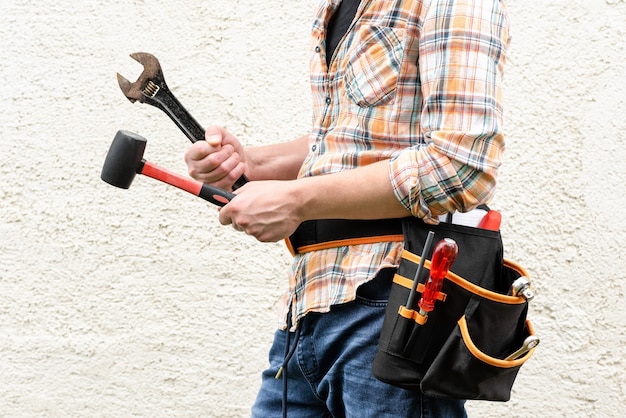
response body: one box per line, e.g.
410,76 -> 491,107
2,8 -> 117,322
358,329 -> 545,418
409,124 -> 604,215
117,52 -> 248,190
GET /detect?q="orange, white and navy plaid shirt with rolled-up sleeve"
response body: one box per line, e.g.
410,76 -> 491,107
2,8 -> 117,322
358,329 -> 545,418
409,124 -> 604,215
281,0 -> 509,328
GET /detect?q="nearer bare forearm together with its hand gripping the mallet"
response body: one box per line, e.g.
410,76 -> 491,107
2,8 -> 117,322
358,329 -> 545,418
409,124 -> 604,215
219,156 -> 410,242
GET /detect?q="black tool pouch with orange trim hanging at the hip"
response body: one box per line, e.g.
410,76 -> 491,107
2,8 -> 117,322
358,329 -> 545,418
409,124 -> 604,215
373,218 -> 534,401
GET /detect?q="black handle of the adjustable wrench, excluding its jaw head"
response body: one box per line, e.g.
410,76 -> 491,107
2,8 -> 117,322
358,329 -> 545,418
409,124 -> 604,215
144,82 -> 250,190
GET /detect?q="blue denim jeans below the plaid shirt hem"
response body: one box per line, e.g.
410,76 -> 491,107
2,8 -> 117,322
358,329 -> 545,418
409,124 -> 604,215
252,271 -> 467,418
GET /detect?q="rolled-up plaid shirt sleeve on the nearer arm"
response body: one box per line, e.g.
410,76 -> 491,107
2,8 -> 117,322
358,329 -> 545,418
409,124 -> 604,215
389,0 -> 510,222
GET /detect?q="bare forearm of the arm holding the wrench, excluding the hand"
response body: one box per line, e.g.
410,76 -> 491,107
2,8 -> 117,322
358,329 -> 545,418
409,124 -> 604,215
246,135 -> 309,180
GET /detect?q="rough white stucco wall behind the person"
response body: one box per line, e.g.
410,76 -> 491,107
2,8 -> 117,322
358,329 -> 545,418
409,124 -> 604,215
0,0 -> 626,417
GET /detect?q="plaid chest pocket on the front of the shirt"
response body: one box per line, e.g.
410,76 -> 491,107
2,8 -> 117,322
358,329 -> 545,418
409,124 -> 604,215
345,26 -> 406,107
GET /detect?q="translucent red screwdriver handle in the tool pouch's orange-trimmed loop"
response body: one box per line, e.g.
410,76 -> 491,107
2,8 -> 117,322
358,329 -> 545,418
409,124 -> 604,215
418,238 -> 459,316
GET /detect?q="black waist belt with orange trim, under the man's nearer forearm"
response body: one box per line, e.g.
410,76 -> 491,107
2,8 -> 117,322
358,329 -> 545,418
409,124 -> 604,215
285,219 -> 404,255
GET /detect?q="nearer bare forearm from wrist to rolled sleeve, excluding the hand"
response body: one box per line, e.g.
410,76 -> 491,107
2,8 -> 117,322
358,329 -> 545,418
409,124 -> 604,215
293,161 -> 410,221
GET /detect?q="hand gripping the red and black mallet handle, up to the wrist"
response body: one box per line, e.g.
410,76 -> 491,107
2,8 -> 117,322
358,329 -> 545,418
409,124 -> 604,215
219,180 -> 302,242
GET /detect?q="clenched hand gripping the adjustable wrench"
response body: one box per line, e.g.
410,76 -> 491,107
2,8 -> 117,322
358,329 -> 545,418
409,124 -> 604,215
185,126 -> 246,190
